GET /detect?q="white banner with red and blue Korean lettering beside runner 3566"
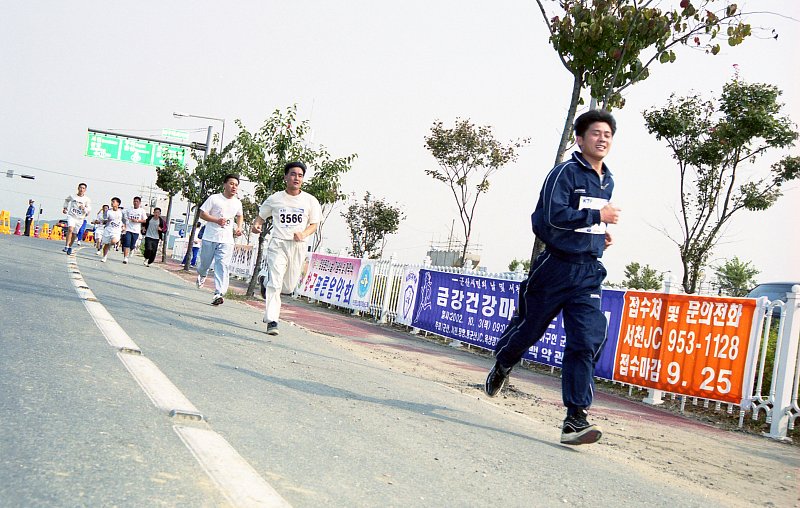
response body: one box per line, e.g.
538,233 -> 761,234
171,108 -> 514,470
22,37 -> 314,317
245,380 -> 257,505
297,252 -> 361,307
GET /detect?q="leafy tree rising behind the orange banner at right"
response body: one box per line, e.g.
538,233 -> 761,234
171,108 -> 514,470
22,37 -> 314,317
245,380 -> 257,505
644,79 -> 800,293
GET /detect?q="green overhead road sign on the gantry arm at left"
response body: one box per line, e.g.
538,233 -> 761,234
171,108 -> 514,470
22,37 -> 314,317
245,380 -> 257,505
86,132 -> 186,166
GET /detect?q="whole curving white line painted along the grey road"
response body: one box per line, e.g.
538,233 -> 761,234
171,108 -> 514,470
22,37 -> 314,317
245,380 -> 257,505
67,251 -> 291,508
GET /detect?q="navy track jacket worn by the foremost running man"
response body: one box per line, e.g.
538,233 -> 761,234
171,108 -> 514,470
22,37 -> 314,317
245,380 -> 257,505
531,152 -> 614,259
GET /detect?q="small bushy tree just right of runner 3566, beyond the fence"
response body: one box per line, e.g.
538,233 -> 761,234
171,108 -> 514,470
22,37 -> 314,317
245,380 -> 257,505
342,192 -> 405,259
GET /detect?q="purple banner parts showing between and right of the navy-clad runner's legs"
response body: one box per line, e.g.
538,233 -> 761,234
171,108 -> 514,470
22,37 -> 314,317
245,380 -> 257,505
522,289 -> 625,379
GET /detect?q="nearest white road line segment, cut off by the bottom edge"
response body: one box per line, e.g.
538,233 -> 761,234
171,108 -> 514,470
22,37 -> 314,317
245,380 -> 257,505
173,425 -> 291,508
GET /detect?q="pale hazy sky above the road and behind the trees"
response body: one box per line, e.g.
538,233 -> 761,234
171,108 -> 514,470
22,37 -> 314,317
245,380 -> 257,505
0,0 -> 800,282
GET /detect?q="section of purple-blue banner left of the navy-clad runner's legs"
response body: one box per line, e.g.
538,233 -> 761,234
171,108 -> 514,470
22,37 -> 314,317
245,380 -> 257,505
411,269 -> 519,349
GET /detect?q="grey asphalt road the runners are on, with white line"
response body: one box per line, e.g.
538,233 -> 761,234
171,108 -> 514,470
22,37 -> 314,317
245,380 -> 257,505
0,235 -> 797,507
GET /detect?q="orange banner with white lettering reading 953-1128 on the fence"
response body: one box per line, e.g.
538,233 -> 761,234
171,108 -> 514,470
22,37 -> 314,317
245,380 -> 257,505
614,291 -> 756,404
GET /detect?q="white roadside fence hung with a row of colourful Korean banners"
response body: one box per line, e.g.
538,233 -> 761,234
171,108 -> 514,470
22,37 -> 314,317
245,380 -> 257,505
167,246 -> 800,438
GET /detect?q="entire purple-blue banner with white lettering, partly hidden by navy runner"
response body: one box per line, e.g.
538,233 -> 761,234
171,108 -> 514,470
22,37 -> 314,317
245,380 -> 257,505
412,269 -> 625,379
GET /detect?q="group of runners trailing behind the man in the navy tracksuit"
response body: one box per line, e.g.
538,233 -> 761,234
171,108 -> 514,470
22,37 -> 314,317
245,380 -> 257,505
64,161 -> 322,335
